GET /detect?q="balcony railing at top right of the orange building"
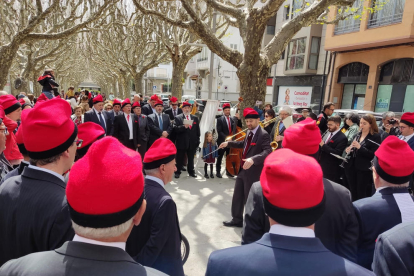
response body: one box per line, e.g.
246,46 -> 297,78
368,0 -> 405,28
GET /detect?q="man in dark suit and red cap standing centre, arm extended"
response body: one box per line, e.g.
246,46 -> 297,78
219,108 -> 272,227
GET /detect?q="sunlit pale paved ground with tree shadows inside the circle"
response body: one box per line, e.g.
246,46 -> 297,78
166,165 -> 241,276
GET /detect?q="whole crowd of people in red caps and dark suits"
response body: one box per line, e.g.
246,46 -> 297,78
0,71 -> 414,276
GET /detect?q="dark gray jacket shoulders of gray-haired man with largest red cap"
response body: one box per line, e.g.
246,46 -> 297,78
0,241 -> 165,276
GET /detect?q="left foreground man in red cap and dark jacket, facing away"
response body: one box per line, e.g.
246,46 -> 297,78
0,98 -> 80,265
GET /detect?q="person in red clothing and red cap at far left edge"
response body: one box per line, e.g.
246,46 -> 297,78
0,95 -> 23,166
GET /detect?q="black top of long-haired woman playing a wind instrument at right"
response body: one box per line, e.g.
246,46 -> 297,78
354,133 -> 381,171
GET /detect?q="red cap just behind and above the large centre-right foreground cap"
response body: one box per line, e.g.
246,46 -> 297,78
282,118 -> 322,155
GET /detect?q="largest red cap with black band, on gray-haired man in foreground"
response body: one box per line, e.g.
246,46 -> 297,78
66,137 -> 144,228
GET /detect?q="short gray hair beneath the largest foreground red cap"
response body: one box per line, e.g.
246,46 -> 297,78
72,217 -> 134,240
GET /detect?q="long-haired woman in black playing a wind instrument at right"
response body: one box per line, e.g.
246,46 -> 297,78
345,114 -> 381,201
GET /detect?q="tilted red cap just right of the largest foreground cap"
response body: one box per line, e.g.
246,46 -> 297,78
144,138 -> 177,170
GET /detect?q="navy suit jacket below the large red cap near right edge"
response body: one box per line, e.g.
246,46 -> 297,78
354,188 -> 408,269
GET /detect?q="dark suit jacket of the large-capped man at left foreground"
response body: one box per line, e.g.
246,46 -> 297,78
0,167 -> 74,265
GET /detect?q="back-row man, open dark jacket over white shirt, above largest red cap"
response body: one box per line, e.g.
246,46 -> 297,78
113,98 -> 139,150
